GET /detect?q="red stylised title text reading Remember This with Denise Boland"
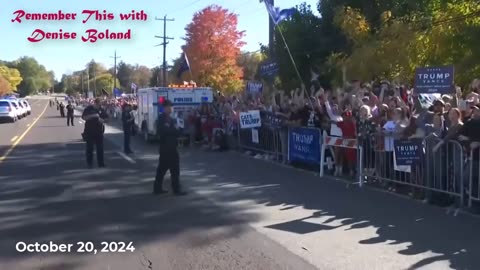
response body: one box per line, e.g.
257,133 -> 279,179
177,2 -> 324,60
12,10 -> 148,43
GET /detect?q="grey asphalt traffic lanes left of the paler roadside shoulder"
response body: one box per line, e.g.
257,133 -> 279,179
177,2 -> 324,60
0,101 -> 315,270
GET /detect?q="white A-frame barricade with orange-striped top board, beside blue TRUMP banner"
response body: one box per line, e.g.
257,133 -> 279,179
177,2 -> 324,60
320,132 -> 364,187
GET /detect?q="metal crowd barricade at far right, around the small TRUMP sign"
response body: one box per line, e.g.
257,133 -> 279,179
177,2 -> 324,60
359,133 -> 465,203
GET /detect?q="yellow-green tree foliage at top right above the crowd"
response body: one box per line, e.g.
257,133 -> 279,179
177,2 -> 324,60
332,0 -> 480,86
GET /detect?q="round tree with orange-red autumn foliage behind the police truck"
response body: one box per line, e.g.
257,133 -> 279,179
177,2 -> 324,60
183,5 -> 245,93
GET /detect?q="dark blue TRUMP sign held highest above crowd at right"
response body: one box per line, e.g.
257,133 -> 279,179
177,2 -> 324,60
415,65 -> 455,95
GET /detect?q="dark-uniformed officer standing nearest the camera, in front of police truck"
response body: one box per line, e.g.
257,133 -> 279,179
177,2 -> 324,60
153,100 -> 187,196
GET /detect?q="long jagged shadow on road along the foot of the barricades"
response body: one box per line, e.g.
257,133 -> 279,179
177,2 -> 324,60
177,151 -> 480,269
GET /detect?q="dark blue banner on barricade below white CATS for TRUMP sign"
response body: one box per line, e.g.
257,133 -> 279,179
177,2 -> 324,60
237,125 -> 282,159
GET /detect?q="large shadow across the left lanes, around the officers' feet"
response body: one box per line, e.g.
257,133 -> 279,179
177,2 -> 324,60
0,141 -> 258,269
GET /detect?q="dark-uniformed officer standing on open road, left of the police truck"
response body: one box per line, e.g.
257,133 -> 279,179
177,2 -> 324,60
82,98 -> 108,168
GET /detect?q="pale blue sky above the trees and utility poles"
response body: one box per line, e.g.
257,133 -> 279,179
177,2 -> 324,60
0,0 -> 317,79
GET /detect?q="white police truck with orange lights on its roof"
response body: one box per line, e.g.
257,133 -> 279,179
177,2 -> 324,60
139,85 -> 213,142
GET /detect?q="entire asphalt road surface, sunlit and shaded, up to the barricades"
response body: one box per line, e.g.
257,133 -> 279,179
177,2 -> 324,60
0,100 -> 480,270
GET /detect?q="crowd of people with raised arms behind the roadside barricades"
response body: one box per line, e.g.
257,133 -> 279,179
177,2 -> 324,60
70,80 -> 480,212
